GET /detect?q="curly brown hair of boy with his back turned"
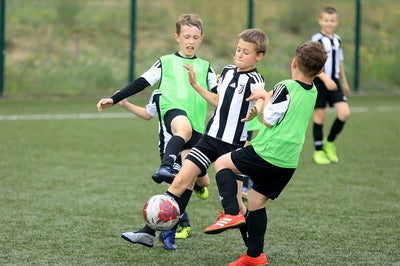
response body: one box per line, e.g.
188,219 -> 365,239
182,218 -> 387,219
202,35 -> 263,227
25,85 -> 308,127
295,41 -> 328,77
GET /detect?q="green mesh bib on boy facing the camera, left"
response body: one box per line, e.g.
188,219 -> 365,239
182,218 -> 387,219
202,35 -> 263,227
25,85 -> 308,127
159,54 -> 210,133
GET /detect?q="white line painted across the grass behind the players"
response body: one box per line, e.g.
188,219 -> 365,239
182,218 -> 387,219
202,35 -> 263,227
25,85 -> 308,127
0,106 -> 400,121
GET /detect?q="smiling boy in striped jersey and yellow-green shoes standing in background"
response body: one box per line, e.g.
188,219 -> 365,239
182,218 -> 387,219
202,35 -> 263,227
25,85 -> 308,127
311,7 -> 350,164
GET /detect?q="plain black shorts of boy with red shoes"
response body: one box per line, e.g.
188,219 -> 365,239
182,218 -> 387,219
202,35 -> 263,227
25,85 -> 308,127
231,145 -> 296,200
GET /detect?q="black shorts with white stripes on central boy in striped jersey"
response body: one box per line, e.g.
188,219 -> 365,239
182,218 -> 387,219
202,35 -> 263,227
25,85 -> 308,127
186,135 -> 244,176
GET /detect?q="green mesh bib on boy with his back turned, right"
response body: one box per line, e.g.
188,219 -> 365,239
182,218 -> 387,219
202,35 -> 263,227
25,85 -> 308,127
251,80 -> 317,168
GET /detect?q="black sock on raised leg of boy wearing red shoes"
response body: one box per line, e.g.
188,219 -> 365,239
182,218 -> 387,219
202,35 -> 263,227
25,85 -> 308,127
215,168 -> 239,215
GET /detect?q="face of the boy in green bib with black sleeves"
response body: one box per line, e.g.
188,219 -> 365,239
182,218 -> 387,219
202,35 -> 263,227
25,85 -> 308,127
174,25 -> 203,58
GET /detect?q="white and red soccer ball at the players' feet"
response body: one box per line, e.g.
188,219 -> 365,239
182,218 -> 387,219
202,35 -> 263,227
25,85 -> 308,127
143,194 -> 180,231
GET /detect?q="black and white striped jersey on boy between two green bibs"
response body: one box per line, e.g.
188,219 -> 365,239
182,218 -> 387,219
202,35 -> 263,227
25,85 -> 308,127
205,65 -> 265,144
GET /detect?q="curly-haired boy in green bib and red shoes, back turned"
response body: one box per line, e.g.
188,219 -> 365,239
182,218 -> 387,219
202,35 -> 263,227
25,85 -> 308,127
208,42 -> 327,265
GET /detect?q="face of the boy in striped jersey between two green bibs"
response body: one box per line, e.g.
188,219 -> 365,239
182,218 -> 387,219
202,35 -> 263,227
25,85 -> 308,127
233,39 -> 264,72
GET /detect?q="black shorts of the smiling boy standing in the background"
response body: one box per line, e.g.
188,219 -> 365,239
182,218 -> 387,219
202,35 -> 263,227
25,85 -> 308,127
313,77 -> 347,108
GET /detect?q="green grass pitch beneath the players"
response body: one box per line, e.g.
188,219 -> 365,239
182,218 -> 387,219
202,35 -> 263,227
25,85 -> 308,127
0,95 -> 400,265
